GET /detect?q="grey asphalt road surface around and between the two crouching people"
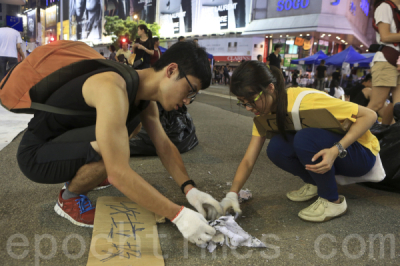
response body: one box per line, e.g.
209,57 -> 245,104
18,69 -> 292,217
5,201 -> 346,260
0,86 -> 400,266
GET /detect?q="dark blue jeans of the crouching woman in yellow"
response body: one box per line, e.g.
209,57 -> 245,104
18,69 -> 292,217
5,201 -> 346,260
267,128 -> 376,201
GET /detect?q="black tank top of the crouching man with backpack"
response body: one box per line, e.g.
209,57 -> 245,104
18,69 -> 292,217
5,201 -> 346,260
28,67 -> 149,141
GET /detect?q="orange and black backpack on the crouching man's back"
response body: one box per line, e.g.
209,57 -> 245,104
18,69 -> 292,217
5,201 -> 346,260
0,41 -> 139,115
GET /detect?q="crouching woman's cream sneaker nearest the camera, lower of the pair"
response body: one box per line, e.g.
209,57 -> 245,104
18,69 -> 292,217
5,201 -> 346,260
299,195 -> 347,222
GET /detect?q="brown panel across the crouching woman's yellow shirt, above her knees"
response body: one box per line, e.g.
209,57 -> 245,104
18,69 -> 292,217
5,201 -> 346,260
254,109 -> 352,138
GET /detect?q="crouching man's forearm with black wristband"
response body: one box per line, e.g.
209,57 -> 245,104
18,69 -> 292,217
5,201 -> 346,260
157,141 -> 190,190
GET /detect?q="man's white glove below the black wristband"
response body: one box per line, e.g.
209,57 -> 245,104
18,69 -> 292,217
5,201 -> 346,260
186,188 -> 222,220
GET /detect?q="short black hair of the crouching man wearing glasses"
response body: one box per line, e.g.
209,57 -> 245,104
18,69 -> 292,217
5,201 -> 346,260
153,41 -> 211,90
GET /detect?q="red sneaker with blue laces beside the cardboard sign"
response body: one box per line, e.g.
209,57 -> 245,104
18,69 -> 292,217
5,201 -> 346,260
54,189 -> 96,228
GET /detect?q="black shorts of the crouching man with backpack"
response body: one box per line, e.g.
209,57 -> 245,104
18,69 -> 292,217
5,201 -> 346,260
17,126 -> 101,184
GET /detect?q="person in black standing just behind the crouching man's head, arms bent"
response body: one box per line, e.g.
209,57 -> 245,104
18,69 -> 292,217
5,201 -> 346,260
132,24 -> 154,69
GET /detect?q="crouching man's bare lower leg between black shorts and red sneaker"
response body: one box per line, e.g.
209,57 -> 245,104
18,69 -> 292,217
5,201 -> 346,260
68,160 -> 107,194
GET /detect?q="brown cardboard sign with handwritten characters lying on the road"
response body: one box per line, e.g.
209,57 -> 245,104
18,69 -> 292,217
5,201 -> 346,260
87,197 -> 164,266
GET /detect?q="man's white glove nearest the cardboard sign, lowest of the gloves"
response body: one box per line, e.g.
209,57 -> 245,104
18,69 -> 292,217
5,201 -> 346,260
171,207 -> 216,245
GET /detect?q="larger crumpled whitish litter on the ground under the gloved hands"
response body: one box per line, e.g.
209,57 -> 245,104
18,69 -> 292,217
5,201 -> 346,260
198,215 -> 266,252
